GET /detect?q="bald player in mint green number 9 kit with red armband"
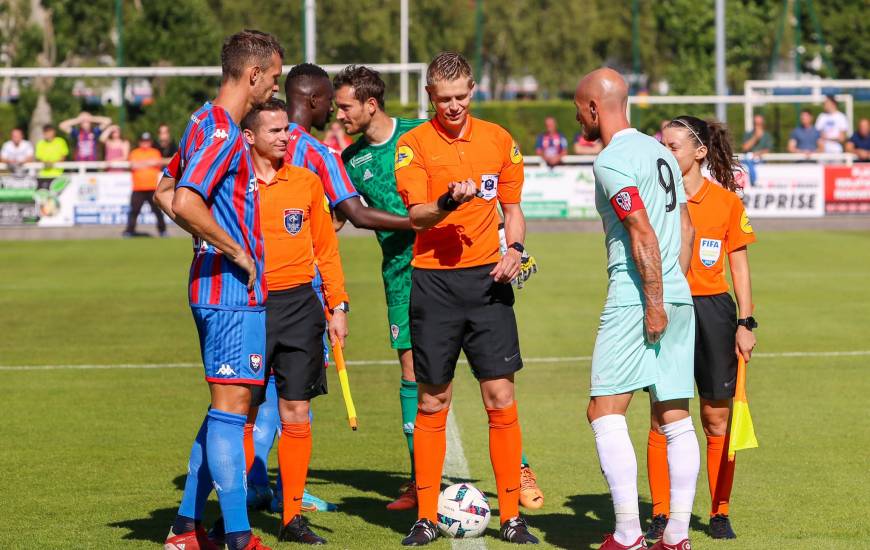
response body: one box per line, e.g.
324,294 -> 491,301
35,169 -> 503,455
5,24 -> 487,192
574,69 -> 701,550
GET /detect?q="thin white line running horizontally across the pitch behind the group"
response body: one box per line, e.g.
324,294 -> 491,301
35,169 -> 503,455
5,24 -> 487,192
0,350 -> 870,371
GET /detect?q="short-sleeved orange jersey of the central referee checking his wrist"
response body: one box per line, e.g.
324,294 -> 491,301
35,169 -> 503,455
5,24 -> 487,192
396,116 -> 523,269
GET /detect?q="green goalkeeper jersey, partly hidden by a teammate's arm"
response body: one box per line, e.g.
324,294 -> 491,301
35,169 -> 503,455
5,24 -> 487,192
341,118 -> 426,306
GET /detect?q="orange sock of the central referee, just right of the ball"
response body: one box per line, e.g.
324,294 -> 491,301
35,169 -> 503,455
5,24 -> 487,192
486,401 -> 523,523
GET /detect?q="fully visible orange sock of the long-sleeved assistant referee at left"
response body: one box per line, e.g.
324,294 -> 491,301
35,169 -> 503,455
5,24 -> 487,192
278,422 -> 311,524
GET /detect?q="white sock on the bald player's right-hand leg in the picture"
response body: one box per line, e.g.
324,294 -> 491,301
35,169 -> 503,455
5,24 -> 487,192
661,417 -> 701,544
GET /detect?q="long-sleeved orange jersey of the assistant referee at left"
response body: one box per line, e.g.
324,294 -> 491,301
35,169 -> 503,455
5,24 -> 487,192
258,164 -> 348,309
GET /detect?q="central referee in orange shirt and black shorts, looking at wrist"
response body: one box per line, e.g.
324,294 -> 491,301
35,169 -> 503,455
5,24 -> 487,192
396,52 -> 538,546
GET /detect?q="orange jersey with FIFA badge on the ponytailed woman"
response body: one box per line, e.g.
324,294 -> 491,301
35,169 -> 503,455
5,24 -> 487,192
686,179 -> 755,296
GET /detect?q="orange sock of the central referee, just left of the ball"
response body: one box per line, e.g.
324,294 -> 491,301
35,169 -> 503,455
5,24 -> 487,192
414,407 -> 446,522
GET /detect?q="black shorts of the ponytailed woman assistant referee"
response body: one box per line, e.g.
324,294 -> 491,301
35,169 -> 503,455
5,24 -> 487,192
692,292 -> 737,401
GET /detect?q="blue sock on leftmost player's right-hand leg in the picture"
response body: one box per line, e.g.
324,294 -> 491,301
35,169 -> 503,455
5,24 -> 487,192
205,409 -> 251,548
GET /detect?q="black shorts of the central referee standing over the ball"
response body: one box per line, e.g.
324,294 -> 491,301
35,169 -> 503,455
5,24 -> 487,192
409,264 -> 523,384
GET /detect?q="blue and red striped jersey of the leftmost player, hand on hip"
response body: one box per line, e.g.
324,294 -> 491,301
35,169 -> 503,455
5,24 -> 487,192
165,103 -> 267,309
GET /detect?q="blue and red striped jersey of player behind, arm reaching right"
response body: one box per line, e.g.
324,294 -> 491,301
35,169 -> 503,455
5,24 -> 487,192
284,122 -> 359,208
